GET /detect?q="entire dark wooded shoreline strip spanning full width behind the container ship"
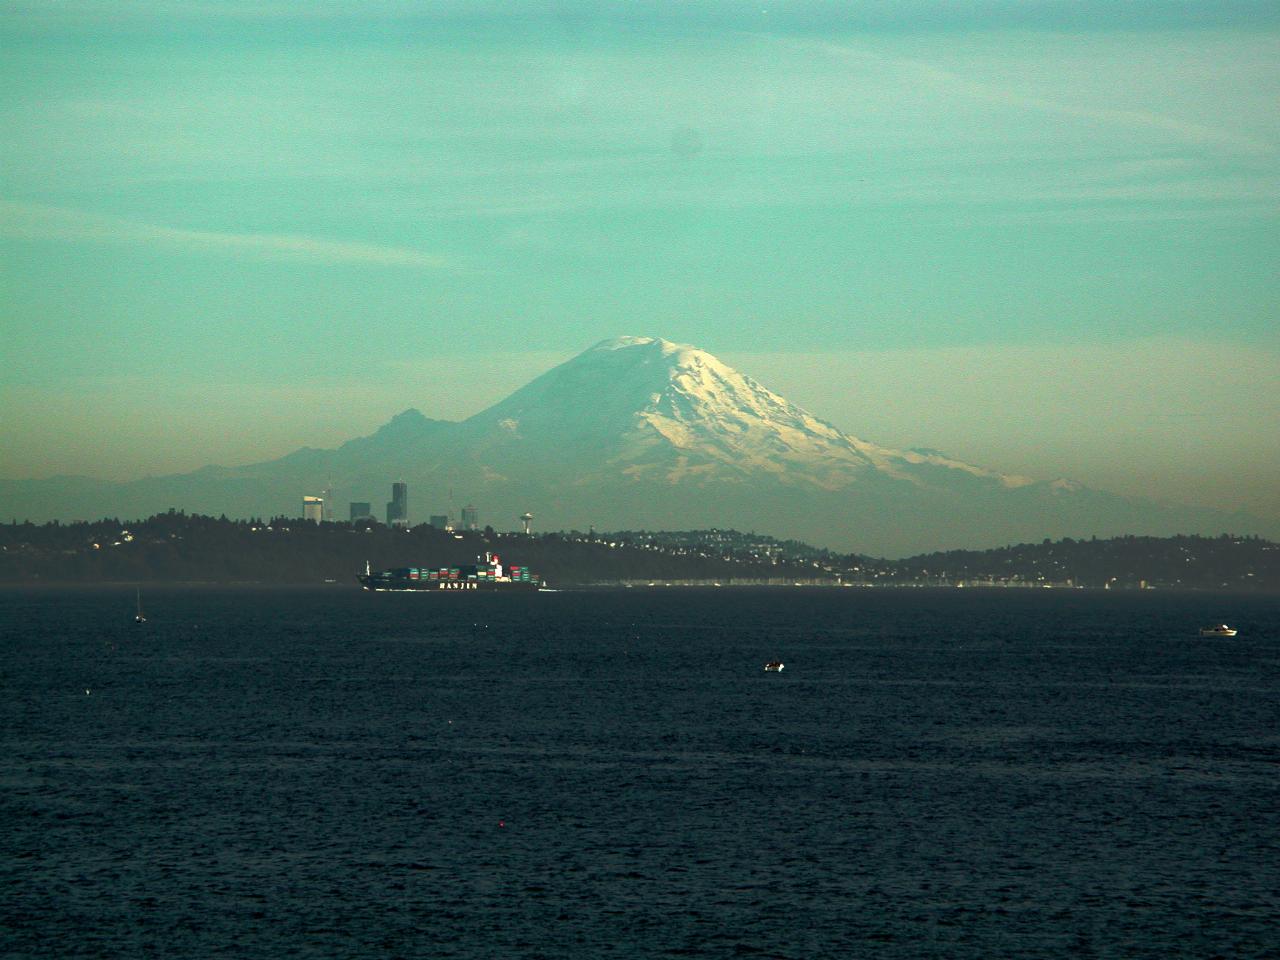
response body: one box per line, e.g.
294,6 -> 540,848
0,511 -> 1280,591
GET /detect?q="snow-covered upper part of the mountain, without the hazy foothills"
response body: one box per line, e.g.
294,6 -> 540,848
450,337 -> 1032,490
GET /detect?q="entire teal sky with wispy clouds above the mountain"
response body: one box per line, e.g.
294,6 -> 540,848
0,0 -> 1280,527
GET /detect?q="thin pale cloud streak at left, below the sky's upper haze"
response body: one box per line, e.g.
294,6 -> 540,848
0,201 -> 451,270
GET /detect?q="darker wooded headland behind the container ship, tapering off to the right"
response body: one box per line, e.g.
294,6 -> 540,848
0,512 -> 831,585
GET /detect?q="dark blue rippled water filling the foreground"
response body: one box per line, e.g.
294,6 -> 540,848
0,589 -> 1280,960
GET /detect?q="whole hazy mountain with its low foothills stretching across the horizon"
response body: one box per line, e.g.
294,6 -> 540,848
0,337 -> 1276,557
